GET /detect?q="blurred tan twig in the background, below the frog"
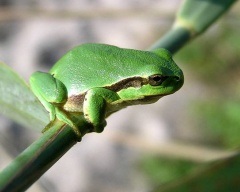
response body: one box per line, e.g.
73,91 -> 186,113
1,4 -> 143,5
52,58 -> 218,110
106,130 -> 239,163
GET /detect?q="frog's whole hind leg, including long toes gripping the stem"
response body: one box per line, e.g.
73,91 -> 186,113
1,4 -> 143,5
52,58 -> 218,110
30,72 -> 81,137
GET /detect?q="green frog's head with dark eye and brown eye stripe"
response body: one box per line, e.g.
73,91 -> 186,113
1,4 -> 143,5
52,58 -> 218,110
119,49 -> 184,104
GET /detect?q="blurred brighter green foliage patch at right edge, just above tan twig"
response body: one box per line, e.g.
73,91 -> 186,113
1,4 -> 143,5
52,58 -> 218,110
195,98 -> 240,149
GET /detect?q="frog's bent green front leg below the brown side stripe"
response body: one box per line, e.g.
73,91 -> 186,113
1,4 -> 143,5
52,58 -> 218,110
83,88 -> 120,133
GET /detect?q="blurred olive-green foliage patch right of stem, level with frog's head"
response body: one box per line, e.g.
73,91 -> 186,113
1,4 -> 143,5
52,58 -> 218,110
178,24 -> 240,85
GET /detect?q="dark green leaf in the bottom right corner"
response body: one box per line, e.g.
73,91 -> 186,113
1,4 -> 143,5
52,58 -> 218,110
154,153 -> 240,192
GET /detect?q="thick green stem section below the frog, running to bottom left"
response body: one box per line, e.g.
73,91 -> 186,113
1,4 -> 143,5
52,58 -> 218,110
0,121 -> 80,192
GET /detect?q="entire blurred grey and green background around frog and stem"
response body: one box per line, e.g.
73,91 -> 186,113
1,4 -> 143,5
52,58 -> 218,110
0,0 -> 240,192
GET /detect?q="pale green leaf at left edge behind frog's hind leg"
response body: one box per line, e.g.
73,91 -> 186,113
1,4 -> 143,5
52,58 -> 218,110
0,63 -> 49,130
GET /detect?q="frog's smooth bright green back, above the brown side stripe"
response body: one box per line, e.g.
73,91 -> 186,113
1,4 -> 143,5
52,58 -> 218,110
50,44 -> 164,95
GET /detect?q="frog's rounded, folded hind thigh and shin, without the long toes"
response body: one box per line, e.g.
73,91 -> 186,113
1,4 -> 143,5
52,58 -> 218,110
30,72 -> 67,120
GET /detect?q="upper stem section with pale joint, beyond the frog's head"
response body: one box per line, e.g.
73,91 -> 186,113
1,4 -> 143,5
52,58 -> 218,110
150,0 -> 236,54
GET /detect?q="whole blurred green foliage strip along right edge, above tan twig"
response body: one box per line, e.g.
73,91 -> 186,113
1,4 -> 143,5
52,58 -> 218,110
180,24 -> 240,148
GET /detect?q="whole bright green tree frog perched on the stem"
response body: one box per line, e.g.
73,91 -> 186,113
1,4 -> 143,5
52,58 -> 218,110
30,44 -> 184,138
